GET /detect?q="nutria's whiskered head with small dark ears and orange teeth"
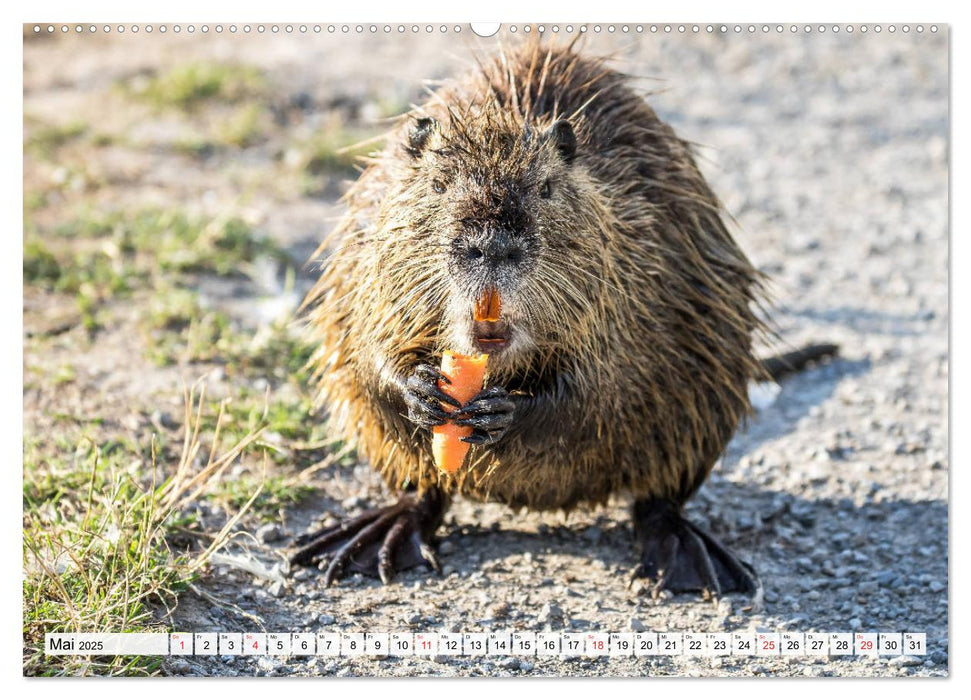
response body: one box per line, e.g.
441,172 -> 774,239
383,103 -> 606,367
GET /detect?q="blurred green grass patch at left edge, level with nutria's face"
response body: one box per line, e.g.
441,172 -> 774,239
23,210 -> 298,360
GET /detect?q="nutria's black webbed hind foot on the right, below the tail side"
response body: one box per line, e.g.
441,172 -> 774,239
631,499 -> 762,598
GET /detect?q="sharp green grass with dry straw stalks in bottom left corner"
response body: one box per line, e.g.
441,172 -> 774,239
23,386 -> 274,676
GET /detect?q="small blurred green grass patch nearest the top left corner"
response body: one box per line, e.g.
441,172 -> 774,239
129,62 -> 265,111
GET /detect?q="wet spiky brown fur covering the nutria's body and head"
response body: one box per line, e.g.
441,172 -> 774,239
305,42 -> 764,509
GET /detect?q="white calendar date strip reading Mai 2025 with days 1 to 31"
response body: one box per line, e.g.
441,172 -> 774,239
44,631 -> 927,658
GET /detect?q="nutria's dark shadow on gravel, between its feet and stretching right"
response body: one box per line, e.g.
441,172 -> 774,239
430,490 -> 947,583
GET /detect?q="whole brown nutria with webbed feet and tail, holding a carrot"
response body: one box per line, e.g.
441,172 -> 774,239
292,42 -> 832,595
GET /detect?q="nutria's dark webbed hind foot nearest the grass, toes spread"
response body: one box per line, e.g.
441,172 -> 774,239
290,489 -> 448,586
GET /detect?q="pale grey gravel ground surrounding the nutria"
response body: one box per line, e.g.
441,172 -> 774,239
25,29 -> 949,676
